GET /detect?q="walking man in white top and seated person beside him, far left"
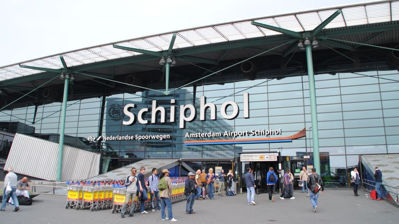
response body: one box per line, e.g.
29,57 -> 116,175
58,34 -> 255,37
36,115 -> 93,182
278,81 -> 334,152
0,168 -> 30,212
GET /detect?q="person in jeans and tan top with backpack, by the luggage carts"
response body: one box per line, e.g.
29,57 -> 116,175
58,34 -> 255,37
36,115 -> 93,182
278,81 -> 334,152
159,169 -> 177,222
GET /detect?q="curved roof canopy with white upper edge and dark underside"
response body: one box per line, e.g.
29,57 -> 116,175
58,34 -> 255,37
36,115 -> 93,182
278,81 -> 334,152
0,1 -> 399,109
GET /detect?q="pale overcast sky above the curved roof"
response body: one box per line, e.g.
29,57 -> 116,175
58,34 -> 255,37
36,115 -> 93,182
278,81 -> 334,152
0,0 -> 378,66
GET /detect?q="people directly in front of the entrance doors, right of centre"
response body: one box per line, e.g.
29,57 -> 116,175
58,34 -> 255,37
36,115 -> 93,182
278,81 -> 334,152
244,167 -> 324,212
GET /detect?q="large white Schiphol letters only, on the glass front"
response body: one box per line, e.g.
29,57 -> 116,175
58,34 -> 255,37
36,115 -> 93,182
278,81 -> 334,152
123,93 -> 249,128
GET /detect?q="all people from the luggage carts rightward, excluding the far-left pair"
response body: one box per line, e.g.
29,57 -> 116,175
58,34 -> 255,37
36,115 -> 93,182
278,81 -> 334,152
121,164 -> 388,221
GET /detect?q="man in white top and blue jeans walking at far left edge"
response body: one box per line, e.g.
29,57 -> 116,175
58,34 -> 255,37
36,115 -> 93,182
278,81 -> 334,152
0,168 -> 19,212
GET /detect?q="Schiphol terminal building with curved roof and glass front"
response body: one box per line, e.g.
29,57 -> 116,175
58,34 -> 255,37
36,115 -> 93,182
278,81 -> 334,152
0,1 -> 399,185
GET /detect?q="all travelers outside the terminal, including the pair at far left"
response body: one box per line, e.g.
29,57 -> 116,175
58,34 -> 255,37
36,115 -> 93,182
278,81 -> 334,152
0,164 -> 383,219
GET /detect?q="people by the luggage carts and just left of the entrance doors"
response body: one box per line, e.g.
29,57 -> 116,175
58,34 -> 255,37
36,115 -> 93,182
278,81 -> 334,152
121,167 -> 235,222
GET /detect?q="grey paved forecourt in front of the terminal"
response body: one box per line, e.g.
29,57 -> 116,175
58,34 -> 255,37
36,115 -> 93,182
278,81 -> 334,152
0,189 -> 399,224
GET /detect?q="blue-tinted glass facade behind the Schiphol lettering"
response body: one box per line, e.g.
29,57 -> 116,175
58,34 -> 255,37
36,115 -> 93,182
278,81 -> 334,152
0,70 -> 399,178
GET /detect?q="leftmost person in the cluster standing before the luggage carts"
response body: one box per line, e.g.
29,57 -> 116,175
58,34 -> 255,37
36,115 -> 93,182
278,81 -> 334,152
121,167 -> 137,218
